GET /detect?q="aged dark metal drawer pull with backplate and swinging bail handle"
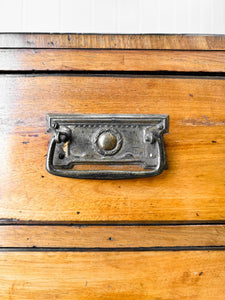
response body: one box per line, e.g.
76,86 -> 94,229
46,114 -> 169,179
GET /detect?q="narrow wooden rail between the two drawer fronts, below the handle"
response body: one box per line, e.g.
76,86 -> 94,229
0,225 -> 225,250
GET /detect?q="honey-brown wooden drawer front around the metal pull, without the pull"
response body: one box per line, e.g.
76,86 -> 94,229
0,75 -> 225,223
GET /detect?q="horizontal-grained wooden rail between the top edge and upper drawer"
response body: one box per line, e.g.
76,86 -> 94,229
0,49 -> 225,72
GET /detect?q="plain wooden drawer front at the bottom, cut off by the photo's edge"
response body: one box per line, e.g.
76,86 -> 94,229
0,251 -> 225,300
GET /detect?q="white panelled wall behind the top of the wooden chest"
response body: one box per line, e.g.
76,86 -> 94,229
0,0 -> 225,34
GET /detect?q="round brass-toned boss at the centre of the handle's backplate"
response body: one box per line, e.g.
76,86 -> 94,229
94,128 -> 122,155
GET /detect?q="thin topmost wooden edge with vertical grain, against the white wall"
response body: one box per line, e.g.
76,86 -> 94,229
0,33 -> 225,50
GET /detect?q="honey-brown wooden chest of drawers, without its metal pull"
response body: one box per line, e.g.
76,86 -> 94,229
0,34 -> 225,299
